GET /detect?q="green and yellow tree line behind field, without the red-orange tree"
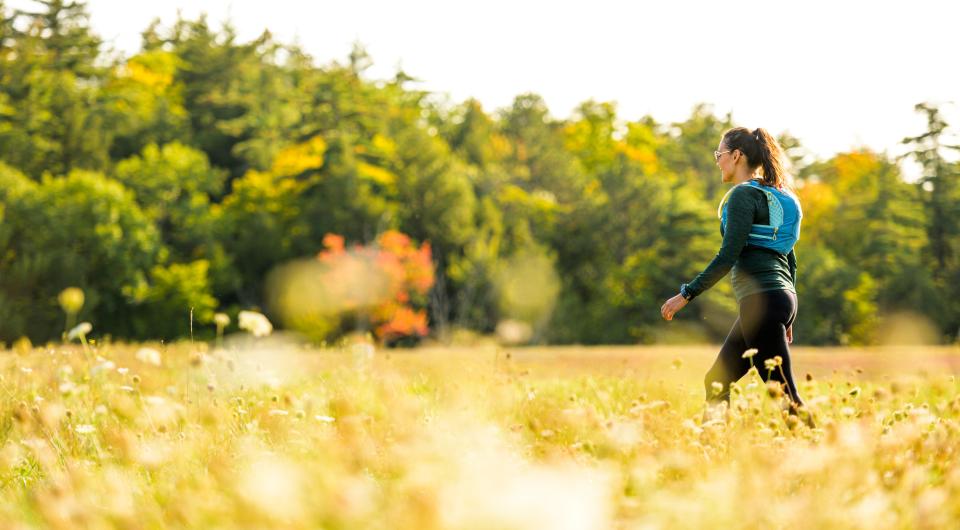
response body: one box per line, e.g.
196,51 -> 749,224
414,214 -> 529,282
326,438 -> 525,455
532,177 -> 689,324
0,0 -> 960,344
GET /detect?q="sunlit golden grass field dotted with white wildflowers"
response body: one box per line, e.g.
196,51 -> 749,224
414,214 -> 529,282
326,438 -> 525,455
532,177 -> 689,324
0,338 -> 960,529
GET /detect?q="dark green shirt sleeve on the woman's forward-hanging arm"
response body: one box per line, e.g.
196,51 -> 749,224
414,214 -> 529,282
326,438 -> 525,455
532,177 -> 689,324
687,186 -> 757,300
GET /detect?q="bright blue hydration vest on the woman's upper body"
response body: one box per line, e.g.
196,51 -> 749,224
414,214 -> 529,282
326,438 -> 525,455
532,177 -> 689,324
717,180 -> 803,255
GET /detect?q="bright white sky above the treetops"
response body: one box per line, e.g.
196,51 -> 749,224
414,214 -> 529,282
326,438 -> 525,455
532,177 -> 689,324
8,0 -> 960,171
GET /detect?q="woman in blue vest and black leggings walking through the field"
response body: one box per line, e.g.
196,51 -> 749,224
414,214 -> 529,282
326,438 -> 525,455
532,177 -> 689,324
660,127 -> 812,424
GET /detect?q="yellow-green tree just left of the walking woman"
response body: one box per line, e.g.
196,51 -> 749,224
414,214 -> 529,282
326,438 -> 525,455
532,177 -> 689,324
554,103 -> 716,343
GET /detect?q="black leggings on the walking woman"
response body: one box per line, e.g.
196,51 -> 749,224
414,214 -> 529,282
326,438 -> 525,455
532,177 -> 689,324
703,290 -> 803,406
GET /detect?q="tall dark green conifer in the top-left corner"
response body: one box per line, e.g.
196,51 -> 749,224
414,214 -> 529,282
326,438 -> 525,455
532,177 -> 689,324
0,0 -> 111,178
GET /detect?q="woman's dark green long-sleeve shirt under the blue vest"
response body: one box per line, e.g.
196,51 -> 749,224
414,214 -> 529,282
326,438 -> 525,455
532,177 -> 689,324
687,186 -> 797,301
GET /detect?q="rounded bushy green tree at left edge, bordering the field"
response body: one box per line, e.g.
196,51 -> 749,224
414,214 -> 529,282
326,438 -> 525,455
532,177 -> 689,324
0,171 -> 160,341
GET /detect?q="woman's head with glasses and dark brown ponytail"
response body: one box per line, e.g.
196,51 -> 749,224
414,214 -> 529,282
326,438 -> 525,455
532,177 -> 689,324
715,127 -> 786,188
